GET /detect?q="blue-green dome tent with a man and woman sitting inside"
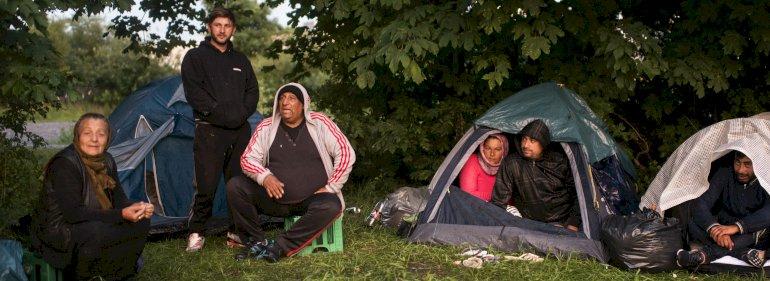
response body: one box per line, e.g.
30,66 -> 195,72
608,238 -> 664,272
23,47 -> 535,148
409,83 -> 638,262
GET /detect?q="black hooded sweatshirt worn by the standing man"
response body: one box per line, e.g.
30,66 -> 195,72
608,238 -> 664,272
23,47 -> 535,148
182,37 -> 259,128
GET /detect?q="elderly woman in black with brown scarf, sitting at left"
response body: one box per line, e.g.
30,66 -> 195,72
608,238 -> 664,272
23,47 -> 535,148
32,113 -> 154,280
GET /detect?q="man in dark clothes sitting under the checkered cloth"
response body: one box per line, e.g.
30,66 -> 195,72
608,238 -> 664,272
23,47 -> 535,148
676,151 -> 770,267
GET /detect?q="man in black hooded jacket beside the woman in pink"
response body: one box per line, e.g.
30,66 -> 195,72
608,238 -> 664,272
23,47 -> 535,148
491,119 -> 581,231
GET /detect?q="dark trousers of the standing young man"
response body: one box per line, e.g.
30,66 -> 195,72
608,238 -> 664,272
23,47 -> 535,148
189,123 -> 251,234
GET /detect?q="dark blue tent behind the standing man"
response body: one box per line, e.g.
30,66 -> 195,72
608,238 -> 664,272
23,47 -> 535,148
108,76 -> 262,233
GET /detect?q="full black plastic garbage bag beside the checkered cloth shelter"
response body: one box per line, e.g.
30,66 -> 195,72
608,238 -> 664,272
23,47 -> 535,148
601,208 -> 682,272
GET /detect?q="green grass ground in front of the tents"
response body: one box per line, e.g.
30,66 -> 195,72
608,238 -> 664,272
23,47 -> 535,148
137,190 -> 761,281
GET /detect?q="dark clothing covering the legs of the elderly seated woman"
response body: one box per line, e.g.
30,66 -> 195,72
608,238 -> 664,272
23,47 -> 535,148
64,220 -> 150,280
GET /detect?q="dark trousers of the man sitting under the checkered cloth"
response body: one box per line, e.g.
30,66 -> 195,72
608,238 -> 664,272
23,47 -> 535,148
687,222 -> 768,261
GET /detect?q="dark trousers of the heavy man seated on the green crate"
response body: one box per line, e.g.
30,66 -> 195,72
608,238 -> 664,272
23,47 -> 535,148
227,176 -> 342,256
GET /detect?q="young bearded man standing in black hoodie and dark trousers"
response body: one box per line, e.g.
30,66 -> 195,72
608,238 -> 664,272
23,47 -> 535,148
182,7 -> 259,252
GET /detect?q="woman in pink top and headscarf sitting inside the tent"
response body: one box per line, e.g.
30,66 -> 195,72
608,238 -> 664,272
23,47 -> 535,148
460,134 -> 508,202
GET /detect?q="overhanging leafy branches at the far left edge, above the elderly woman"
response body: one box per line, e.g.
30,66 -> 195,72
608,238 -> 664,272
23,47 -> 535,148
0,0 -> 158,144
